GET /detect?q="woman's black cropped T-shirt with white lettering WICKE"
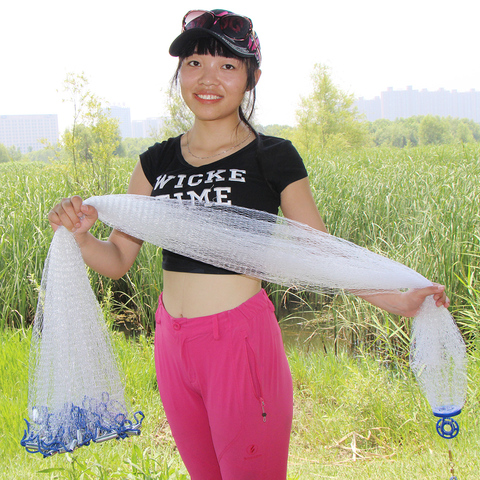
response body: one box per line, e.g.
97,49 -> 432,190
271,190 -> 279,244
140,134 -> 307,274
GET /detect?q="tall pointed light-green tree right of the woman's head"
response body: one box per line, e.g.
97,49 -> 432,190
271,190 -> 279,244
296,64 -> 369,151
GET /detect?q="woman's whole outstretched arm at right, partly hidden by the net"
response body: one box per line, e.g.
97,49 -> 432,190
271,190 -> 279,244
280,178 -> 450,317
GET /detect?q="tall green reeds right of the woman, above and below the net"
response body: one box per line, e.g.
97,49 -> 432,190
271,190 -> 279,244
296,144 -> 480,358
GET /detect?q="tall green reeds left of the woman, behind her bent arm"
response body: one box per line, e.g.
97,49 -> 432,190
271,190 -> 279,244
0,159 -> 161,329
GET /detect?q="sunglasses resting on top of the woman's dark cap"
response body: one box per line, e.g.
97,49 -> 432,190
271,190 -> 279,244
182,10 -> 253,40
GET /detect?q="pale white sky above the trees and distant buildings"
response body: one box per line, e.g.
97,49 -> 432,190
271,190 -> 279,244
0,0 -> 480,130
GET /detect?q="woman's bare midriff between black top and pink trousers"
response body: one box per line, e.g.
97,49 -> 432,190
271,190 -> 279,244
163,270 -> 261,318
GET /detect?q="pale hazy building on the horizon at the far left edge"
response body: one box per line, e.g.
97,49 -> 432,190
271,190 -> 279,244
0,115 -> 58,153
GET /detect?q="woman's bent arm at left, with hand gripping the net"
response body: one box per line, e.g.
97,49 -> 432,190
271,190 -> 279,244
48,162 -> 152,279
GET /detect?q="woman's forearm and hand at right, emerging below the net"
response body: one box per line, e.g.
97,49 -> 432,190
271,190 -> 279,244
362,283 -> 450,317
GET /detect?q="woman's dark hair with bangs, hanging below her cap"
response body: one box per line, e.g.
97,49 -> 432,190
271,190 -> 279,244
172,37 -> 259,132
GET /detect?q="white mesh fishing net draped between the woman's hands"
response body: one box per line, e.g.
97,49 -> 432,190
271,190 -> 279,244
21,195 -> 466,450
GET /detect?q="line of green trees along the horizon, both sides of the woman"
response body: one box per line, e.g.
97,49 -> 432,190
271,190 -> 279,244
0,64 -> 480,165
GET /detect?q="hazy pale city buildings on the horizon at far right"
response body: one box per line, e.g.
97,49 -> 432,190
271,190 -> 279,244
355,87 -> 480,123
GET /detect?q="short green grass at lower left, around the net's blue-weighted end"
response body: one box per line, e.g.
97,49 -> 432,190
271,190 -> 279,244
0,329 -> 186,480
